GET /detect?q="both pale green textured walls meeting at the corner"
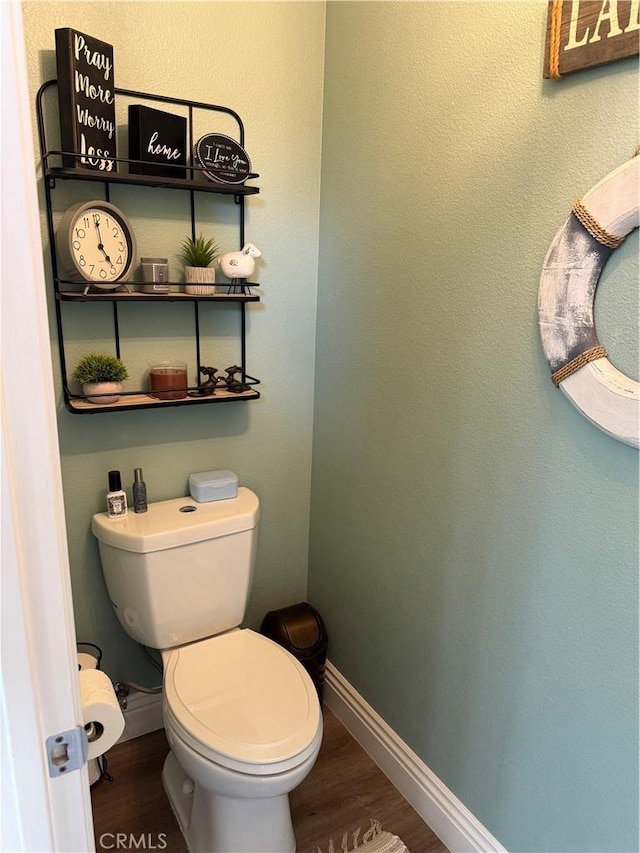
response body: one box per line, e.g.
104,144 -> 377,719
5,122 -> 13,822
23,2 -> 639,853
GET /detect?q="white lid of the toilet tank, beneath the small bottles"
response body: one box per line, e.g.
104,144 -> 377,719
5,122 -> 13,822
91,486 -> 260,554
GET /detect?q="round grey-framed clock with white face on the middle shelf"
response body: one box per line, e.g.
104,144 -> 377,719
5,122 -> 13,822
56,200 -> 136,290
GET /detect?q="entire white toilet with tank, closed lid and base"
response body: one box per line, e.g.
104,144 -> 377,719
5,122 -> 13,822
91,487 -> 322,853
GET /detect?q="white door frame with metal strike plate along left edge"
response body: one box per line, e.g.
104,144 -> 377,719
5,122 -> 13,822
0,0 -> 95,853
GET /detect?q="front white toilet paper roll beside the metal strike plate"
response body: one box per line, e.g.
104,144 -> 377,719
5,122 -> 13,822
78,669 -> 124,759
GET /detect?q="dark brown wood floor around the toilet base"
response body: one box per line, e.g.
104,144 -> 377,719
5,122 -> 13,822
91,708 -> 447,853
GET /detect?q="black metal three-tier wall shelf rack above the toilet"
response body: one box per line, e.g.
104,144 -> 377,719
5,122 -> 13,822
36,80 -> 260,414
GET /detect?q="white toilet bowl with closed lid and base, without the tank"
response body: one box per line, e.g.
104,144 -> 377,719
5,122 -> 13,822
162,629 -> 322,853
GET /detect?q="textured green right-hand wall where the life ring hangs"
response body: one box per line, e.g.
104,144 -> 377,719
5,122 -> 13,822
309,2 -> 638,851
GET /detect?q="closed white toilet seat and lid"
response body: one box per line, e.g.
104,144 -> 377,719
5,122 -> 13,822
164,629 -> 322,775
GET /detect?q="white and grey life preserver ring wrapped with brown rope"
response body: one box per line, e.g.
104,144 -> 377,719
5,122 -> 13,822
538,155 -> 640,447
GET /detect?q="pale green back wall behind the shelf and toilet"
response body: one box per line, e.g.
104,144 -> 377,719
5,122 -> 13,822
24,2 -> 325,680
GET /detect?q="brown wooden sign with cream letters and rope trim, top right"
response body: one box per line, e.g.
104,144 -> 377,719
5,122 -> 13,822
543,0 -> 640,79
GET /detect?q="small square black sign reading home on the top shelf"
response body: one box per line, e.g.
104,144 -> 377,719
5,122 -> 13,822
129,104 -> 187,178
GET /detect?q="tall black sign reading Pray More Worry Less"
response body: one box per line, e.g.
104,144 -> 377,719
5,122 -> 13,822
56,27 -> 117,172
